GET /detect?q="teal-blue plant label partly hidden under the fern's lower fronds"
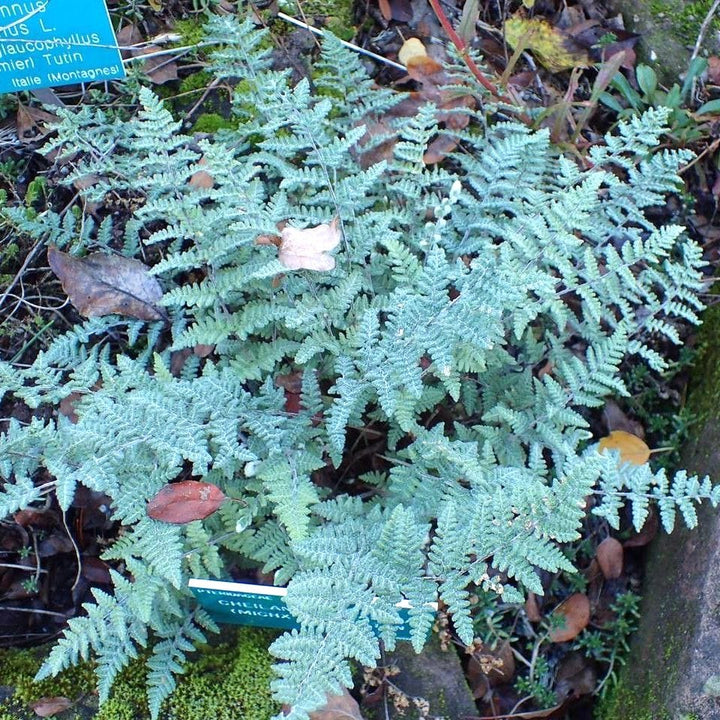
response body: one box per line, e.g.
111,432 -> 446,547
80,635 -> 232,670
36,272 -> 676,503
188,578 -> 437,640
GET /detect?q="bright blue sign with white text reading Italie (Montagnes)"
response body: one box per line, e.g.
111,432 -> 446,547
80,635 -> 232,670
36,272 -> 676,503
0,0 -> 125,93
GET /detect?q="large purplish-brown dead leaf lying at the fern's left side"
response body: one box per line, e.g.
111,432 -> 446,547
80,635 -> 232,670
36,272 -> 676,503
48,246 -> 167,320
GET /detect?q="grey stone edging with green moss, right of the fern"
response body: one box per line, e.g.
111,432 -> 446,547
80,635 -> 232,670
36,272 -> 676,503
598,308 -> 720,720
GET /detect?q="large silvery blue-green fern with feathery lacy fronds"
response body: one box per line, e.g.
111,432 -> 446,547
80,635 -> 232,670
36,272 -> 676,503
0,18 -> 720,719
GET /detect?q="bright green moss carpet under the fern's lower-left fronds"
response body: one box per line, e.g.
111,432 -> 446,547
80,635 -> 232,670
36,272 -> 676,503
0,628 -> 280,720
